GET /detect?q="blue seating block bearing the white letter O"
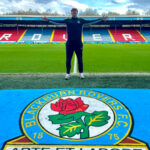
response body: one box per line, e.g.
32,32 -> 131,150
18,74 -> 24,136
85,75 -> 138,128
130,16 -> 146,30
20,28 -> 53,42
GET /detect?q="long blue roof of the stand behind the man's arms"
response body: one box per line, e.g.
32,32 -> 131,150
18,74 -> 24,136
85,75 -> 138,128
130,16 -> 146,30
0,15 -> 150,25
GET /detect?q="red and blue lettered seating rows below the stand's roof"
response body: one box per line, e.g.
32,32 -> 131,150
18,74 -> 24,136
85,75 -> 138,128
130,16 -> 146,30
0,28 -> 150,43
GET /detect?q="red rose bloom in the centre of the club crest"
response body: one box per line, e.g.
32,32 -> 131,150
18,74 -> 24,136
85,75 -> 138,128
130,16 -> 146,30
51,97 -> 89,114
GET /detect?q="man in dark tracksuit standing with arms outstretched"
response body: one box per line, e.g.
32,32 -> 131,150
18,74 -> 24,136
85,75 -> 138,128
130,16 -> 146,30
42,8 -> 106,80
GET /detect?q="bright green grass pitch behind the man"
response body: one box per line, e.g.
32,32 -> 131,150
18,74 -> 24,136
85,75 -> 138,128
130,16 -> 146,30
0,44 -> 150,73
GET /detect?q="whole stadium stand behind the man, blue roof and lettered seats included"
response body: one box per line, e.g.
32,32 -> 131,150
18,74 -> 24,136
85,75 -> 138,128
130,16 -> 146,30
0,16 -> 150,43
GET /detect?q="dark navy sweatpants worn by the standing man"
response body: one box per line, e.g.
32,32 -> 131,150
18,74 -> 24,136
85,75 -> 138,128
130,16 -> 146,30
66,43 -> 83,74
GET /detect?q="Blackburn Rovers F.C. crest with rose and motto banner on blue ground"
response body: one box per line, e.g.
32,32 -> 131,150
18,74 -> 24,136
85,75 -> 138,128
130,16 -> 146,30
4,89 -> 147,150
